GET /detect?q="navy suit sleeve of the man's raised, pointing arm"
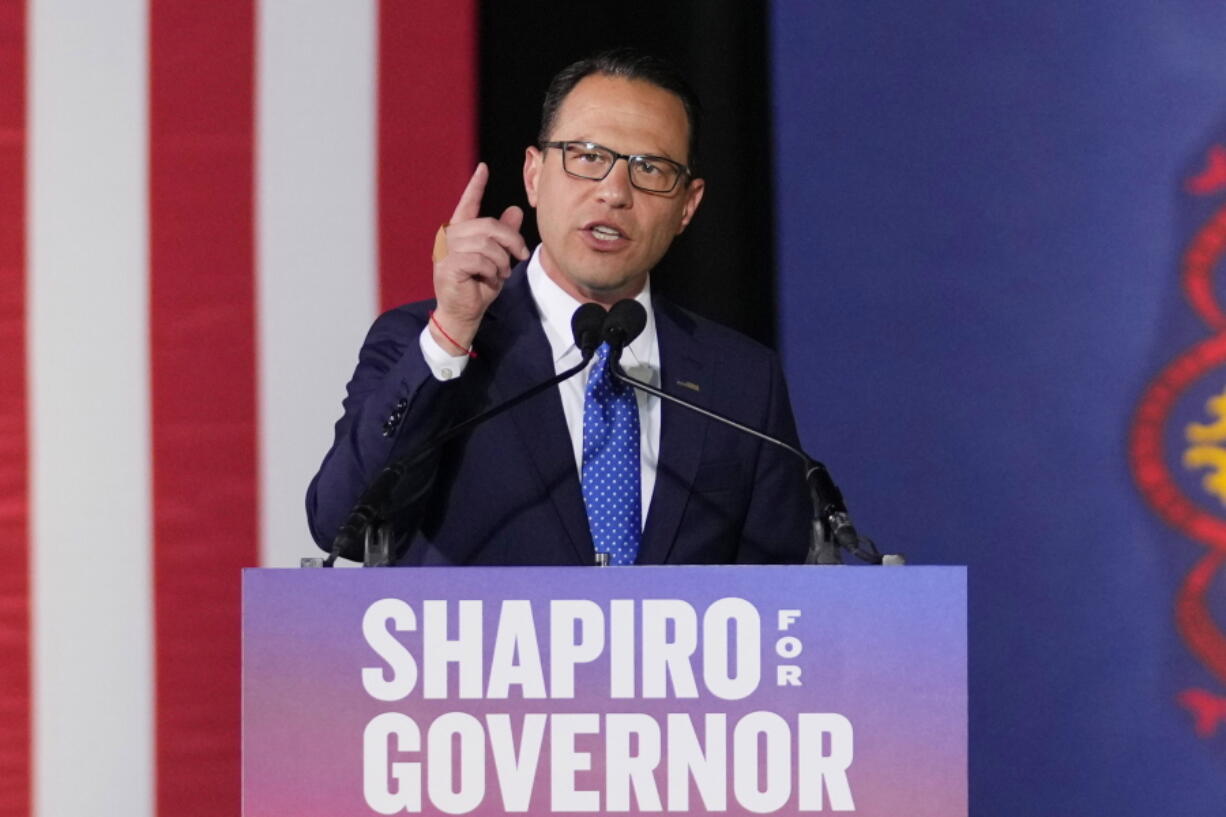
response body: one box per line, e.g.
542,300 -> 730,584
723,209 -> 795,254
307,304 -> 459,558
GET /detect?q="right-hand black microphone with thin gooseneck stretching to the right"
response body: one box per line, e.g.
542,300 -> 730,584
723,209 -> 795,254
604,298 -> 882,564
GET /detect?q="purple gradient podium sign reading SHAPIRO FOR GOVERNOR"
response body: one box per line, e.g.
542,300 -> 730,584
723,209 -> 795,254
243,567 -> 967,817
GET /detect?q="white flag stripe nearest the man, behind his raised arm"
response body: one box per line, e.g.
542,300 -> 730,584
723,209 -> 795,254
256,0 -> 377,567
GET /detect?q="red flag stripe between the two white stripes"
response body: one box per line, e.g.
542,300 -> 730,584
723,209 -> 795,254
150,0 -> 259,817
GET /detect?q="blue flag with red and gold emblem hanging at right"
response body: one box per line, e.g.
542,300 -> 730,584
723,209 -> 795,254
772,0 -> 1226,817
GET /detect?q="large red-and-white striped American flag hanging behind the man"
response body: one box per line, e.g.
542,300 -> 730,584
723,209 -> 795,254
0,0 -> 477,817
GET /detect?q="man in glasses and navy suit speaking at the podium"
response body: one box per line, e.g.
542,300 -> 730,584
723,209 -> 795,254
307,50 -> 809,564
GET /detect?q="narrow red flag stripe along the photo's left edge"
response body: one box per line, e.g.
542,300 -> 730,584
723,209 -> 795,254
0,0 -> 31,817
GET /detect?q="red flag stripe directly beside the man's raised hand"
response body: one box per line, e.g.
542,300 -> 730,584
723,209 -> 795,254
379,0 -> 477,309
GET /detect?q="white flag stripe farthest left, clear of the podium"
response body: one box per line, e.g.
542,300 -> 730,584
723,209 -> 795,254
28,0 -> 153,817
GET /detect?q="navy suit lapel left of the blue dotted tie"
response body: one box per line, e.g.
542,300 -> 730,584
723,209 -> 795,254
478,264 -> 595,564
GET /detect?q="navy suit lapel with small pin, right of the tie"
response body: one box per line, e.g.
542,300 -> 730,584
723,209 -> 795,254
639,298 -> 709,564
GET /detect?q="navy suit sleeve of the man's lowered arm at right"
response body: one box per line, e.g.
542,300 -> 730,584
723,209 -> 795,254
737,353 -> 812,564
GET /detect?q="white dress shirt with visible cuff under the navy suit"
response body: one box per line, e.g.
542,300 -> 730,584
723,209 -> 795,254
421,247 -> 660,525
